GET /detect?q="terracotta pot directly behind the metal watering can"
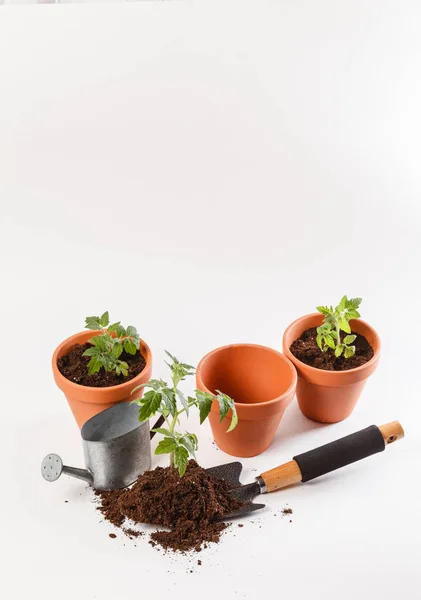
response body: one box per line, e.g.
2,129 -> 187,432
53,331 -> 152,428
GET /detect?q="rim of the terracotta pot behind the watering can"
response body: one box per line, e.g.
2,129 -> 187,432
52,329 -> 152,396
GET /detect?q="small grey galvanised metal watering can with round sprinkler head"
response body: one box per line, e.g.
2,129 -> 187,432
41,402 -> 164,490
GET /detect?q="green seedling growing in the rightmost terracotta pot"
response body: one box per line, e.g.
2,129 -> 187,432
316,296 -> 362,358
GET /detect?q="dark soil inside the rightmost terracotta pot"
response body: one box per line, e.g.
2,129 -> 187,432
289,327 -> 374,371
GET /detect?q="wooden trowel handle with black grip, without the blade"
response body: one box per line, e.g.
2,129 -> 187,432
258,421 -> 404,492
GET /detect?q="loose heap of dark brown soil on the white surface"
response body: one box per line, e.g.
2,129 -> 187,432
96,460 -> 244,552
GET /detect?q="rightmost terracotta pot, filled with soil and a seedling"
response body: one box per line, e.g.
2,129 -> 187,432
282,313 -> 380,423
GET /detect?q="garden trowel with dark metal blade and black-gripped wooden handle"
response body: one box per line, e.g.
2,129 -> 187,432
207,421 -> 404,521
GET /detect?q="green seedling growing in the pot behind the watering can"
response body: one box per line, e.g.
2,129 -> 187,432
83,311 -> 140,375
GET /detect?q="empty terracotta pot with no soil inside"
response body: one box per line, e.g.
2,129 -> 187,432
196,344 -> 297,457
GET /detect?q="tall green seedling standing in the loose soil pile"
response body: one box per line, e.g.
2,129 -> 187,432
132,351 -> 238,477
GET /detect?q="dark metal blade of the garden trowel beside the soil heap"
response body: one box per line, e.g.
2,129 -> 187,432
206,461 -> 265,521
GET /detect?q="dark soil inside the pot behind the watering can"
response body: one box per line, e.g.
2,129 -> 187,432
57,343 -> 146,387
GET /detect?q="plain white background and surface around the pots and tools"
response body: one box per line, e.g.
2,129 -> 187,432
0,0 -> 421,600
